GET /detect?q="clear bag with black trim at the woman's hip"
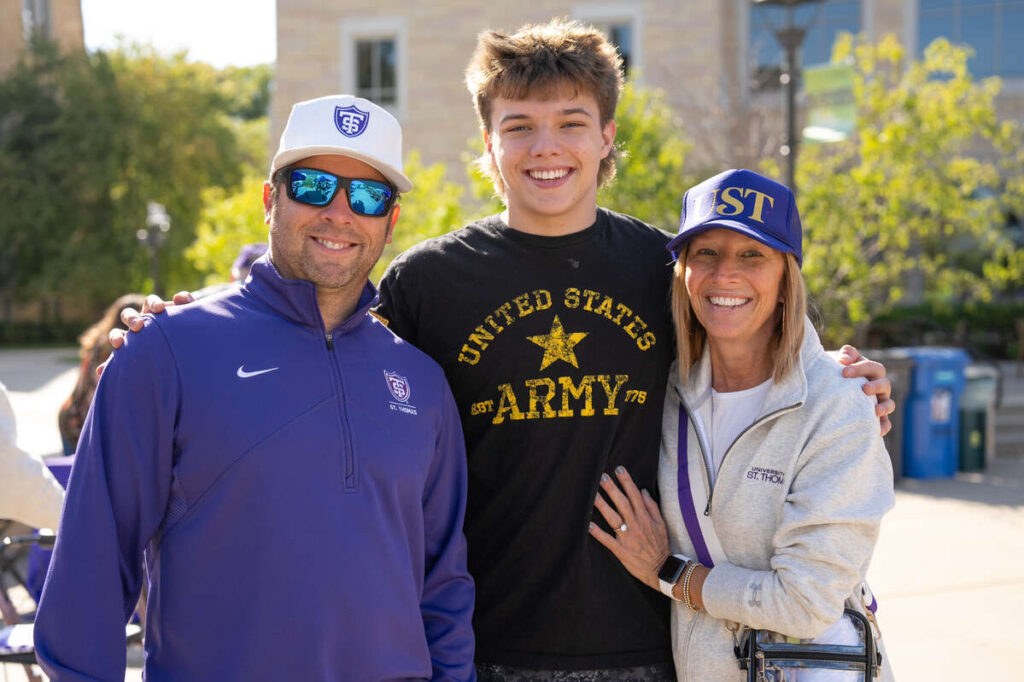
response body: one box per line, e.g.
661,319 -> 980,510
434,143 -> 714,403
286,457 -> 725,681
734,608 -> 882,682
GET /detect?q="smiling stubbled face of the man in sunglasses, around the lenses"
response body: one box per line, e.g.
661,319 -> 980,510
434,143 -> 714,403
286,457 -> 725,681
263,155 -> 398,307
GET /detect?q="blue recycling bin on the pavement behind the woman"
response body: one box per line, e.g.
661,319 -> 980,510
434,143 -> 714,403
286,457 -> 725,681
902,347 -> 971,478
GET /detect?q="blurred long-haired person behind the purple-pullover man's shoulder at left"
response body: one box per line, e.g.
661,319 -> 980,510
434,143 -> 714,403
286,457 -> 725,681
54,294 -> 145,454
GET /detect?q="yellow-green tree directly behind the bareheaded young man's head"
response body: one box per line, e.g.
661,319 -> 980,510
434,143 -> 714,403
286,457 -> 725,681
466,80 -> 694,232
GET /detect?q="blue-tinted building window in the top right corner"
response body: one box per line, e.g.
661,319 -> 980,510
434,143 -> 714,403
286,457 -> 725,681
918,0 -> 1024,78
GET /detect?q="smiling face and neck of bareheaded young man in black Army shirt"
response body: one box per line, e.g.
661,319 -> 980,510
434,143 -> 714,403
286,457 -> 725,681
484,87 -> 615,237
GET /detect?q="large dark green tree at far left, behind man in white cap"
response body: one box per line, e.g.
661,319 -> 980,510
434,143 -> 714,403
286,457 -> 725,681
0,43 -> 266,314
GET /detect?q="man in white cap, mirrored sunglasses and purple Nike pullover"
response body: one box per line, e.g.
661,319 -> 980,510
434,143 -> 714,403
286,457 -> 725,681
36,96 -> 474,682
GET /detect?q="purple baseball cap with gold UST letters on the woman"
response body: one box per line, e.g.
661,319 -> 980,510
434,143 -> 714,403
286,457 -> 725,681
668,169 -> 804,265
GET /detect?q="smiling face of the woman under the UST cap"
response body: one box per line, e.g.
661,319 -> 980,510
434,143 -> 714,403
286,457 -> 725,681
684,227 -> 785,350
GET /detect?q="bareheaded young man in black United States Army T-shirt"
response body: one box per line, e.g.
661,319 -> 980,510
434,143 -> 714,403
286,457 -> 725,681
378,20 -> 893,681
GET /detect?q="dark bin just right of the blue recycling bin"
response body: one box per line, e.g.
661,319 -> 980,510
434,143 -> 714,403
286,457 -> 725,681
959,365 -> 999,471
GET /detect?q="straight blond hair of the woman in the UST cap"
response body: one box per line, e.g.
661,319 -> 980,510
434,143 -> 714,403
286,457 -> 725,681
672,243 -> 807,384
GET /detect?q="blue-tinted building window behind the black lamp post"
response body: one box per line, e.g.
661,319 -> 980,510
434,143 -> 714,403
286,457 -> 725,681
750,0 -> 861,88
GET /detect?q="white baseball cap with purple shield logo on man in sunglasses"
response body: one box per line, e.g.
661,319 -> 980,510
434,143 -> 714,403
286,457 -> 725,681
270,94 -> 413,193
